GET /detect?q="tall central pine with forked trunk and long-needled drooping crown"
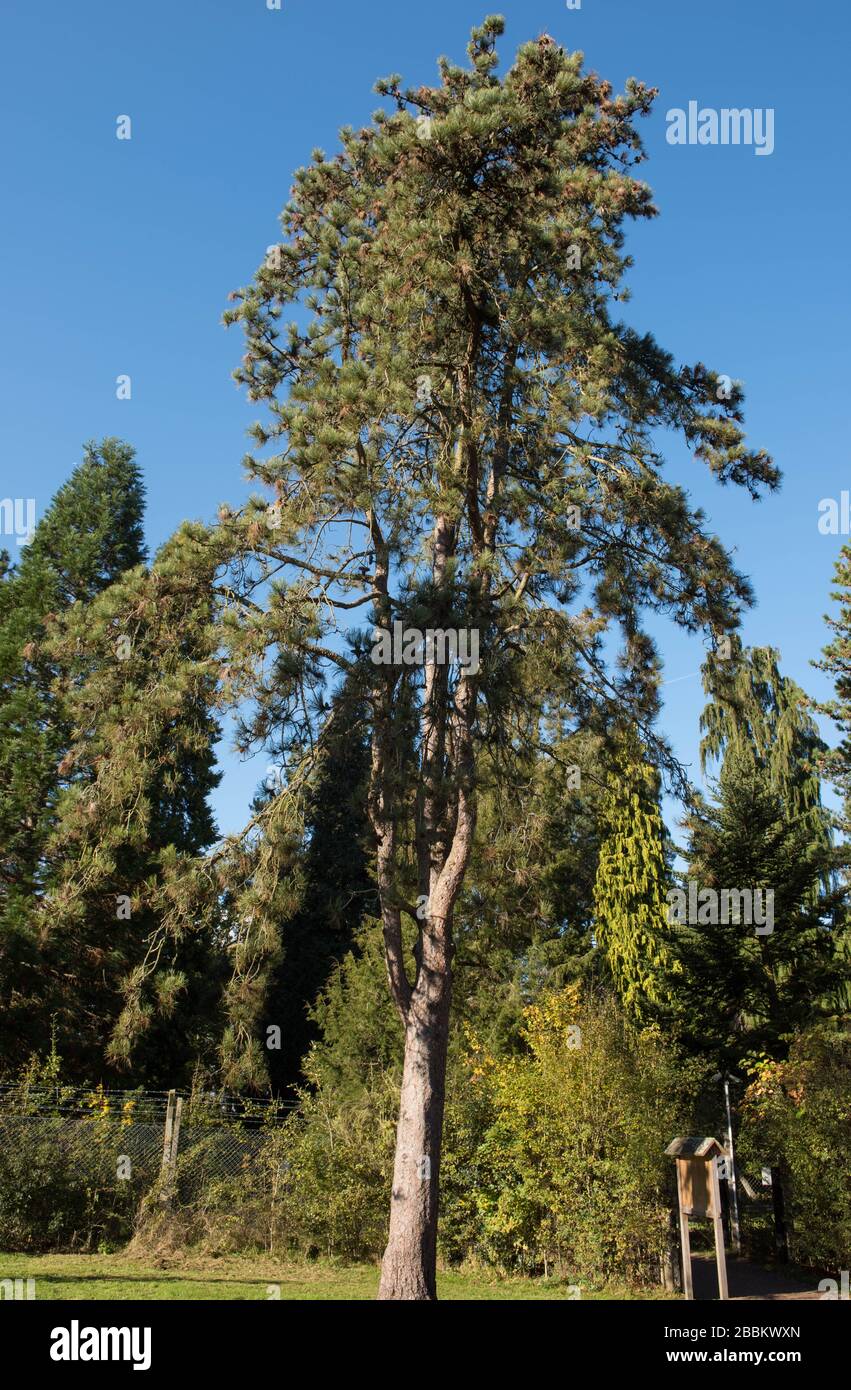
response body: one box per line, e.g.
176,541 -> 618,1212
86,18 -> 777,1300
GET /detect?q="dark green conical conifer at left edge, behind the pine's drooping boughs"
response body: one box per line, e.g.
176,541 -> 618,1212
0,439 -> 145,1068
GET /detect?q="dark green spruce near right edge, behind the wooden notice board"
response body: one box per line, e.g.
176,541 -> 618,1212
680,744 -> 841,1068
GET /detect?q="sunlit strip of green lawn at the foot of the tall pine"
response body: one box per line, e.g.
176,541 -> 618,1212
0,1255 -> 666,1301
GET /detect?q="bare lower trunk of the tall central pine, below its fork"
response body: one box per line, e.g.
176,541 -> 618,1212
378,937 -> 452,1301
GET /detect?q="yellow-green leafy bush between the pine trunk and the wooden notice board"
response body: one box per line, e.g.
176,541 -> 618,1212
442,987 -> 704,1283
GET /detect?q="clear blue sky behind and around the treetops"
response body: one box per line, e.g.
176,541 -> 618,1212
0,0 -> 851,830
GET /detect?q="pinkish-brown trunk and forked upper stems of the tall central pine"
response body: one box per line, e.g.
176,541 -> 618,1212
370,483 -> 476,1301
